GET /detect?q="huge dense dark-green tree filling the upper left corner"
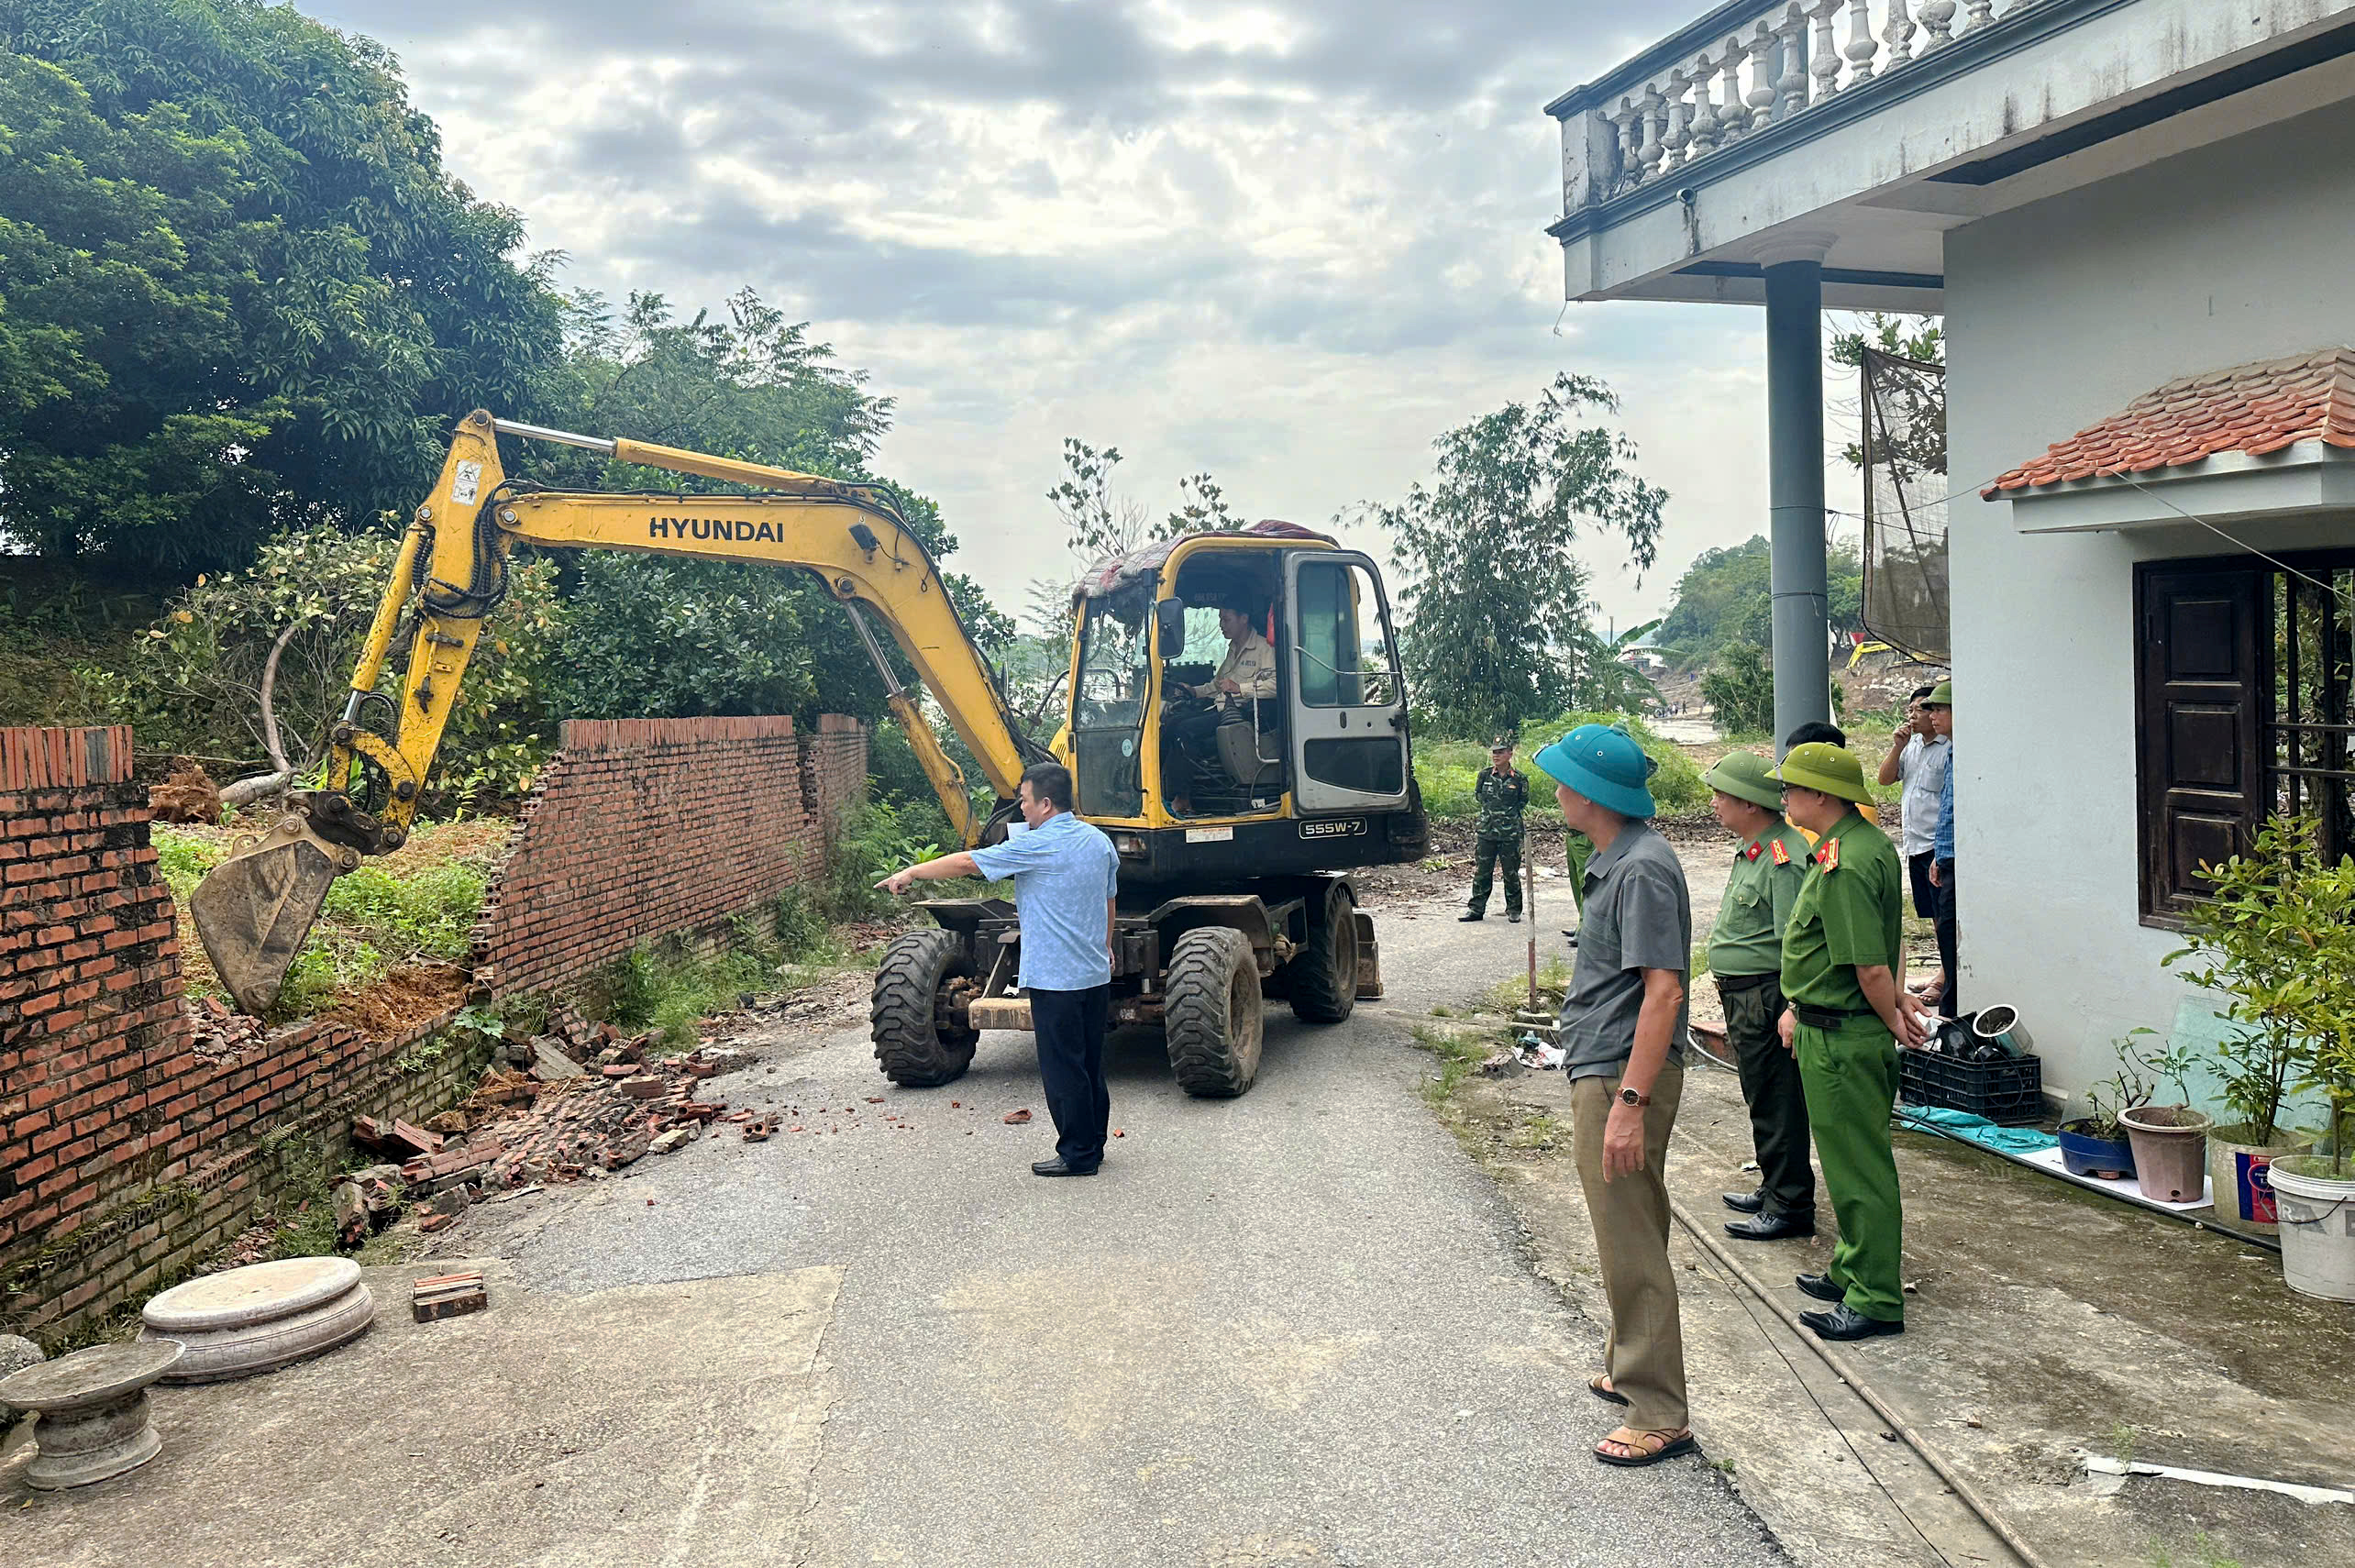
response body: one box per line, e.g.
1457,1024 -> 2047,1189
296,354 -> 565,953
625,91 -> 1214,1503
0,0 -> 560,572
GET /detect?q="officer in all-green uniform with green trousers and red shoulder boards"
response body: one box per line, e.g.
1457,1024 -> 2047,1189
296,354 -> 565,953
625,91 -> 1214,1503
1769,742 -> 1929,1340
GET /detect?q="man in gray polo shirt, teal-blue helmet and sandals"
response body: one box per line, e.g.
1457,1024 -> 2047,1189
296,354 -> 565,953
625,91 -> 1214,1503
1538,725 -> 1693,1467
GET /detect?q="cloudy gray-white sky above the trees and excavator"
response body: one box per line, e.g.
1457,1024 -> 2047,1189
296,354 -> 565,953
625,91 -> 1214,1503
302,0 -> 1840,626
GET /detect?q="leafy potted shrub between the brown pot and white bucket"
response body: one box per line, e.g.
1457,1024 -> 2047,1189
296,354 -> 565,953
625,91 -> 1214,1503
2164,820 -> 2315,1233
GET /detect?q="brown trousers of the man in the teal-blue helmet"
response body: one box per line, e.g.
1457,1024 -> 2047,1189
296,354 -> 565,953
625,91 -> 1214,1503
1571,1066 -> 1691,1431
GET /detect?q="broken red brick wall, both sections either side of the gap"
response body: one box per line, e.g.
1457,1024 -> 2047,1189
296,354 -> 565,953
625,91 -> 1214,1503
0,718 -> 867,1340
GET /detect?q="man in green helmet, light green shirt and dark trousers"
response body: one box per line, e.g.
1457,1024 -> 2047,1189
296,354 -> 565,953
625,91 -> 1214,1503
1703,751 -> 1816,1241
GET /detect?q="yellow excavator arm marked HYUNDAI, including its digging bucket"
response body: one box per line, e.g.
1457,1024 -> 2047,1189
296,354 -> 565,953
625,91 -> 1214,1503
191,410 -> 1045,1012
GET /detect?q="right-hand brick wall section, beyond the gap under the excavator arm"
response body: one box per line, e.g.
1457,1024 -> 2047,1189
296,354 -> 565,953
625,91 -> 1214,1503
476,713 -> 867,991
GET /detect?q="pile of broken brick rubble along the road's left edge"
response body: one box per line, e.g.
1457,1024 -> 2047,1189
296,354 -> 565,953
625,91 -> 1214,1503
337,1021 -> 770,1239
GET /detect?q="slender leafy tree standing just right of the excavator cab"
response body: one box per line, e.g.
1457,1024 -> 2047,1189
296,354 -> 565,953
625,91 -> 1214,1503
1371,374 -> 1667,734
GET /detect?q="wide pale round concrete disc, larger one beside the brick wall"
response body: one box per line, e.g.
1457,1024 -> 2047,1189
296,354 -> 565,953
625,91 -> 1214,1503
139,1257 -> 377,1382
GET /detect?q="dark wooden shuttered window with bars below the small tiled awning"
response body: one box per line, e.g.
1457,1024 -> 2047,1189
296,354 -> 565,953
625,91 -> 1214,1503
2136,551 -> 2355,925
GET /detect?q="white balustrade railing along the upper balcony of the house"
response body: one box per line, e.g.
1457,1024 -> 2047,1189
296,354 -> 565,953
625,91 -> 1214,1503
1552,0 -> 2049,207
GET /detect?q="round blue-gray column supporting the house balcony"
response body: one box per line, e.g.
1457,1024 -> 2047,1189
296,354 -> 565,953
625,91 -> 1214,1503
1762,237 -> 1832,754
